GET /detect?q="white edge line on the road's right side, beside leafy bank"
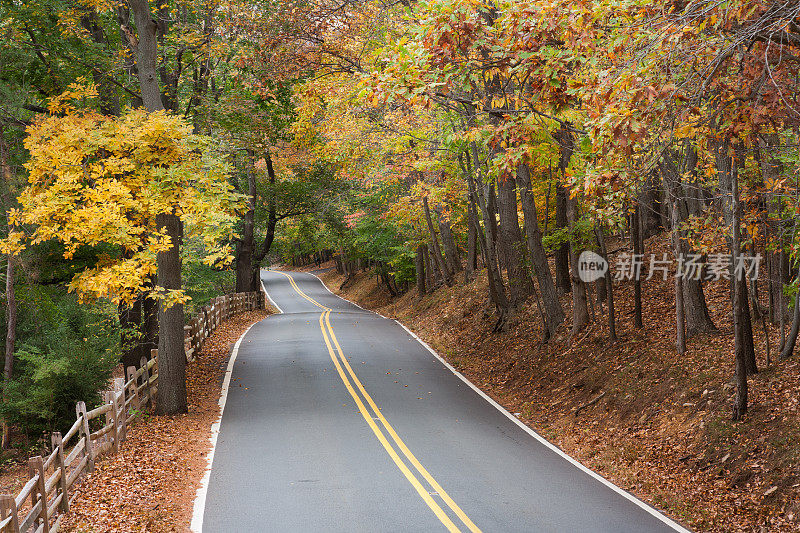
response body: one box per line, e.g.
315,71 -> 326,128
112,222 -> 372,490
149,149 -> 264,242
311,274 -> 691,533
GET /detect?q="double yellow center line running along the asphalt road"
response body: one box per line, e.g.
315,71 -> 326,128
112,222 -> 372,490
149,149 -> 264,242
280,272 -> 480,533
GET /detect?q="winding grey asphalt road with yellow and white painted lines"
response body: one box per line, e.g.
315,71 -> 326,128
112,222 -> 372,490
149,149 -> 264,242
200,271 -> 685,533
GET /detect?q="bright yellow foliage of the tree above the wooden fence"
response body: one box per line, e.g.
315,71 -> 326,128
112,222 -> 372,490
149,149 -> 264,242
4,102 -> 243,307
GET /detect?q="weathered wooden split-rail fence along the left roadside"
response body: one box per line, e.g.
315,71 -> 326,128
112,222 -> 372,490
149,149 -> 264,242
0,292 -> 265,533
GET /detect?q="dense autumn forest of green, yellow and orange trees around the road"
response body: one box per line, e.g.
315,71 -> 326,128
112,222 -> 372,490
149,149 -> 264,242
0,0 -> 800,524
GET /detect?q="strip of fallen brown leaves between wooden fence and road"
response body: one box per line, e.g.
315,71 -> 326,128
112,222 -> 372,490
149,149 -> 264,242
62,311 -> 269,533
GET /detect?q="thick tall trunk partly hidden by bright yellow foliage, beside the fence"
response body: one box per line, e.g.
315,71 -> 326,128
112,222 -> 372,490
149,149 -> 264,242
128,0 -> 187,415
